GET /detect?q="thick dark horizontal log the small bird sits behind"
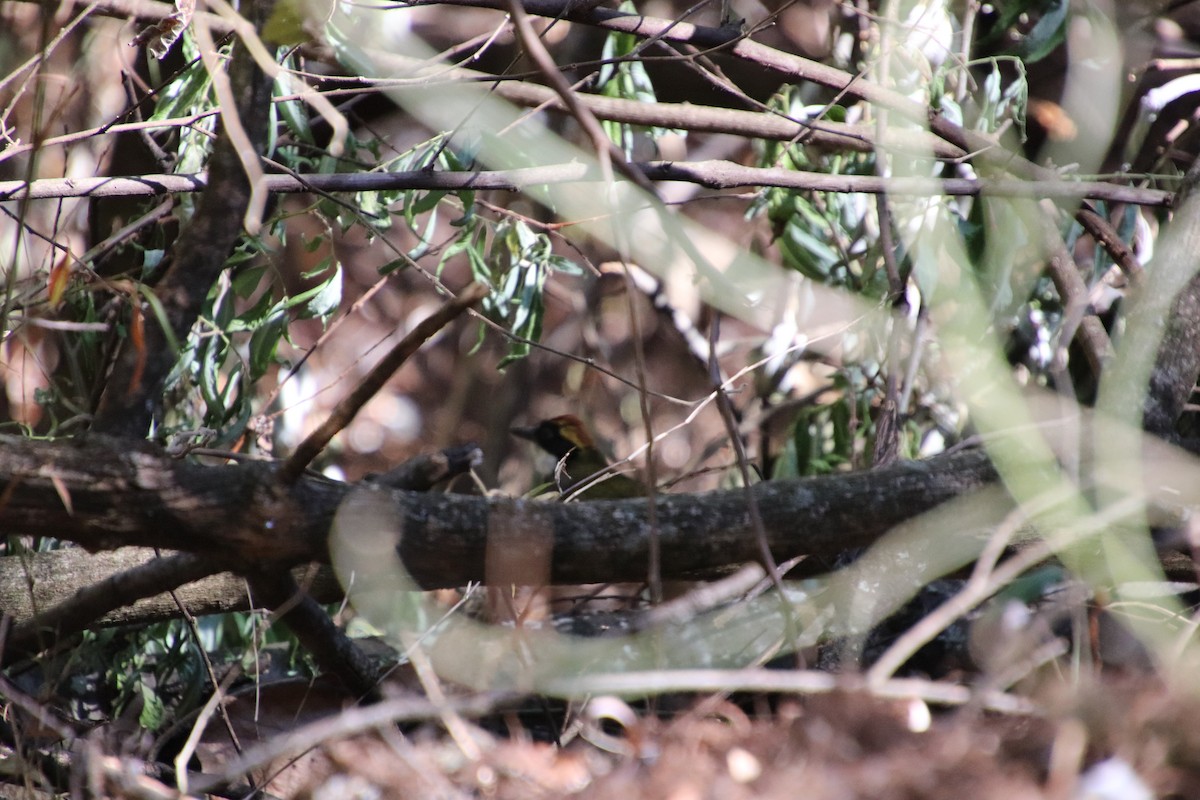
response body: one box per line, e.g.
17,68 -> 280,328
0,435 -> 995,588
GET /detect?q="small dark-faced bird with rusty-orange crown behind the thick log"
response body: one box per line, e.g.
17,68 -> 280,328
512,414 -> 647,500
